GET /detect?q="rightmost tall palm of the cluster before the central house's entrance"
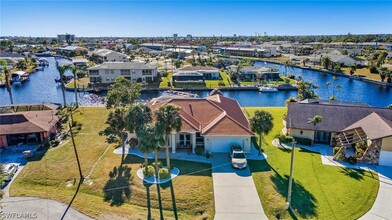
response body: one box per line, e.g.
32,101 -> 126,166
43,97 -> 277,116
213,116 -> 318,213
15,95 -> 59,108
155,104 -> 182,170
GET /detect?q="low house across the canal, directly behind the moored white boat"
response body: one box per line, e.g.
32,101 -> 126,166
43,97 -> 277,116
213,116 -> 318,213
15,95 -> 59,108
238,66 -> 280,80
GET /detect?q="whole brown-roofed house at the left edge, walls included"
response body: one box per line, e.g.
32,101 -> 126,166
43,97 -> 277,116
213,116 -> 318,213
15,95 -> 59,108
0,105 -> 59,148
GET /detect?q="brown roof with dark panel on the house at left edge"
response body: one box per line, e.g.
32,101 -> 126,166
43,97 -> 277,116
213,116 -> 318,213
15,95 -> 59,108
0,110 -> 59,135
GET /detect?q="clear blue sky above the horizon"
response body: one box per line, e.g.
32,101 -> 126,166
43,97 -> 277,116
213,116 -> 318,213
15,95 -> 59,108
0,0 -> 392,37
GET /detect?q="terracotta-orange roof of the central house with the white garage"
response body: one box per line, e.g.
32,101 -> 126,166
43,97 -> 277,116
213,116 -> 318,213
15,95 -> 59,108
148,94 -> 253,135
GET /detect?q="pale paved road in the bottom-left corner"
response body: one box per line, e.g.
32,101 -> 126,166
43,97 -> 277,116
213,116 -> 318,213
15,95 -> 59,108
0,197 -> 92,220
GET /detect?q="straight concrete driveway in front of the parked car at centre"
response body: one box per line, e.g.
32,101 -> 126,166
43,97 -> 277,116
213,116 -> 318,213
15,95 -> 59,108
212,153 -> 268,220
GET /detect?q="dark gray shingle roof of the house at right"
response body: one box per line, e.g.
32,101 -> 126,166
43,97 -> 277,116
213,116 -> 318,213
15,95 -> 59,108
287,102 -> 392,132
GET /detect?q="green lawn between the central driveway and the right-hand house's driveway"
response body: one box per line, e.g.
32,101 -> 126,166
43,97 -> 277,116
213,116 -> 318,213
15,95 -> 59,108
246,107 -> 379,219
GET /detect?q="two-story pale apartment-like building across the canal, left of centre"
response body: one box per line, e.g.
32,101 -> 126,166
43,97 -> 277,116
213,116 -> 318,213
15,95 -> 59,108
87,62 -> 158,84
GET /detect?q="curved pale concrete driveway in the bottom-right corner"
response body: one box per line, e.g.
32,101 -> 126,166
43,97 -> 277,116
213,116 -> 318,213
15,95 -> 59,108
360,166 -> 392,220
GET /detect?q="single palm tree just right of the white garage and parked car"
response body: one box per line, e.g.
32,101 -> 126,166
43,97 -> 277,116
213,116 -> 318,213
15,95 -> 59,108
249,110 -> 274,150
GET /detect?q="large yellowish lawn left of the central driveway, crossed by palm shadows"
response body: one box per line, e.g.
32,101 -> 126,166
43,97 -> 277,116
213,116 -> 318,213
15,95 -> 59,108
10,107 -> 214,219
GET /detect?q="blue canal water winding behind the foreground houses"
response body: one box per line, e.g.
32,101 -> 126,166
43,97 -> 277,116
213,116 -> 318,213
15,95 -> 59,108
0,57 -> 392,107
